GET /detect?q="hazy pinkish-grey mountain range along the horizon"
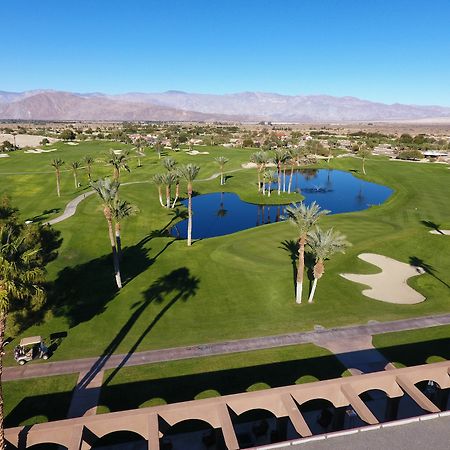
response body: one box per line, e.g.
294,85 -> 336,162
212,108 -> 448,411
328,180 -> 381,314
0,90 -> 450,123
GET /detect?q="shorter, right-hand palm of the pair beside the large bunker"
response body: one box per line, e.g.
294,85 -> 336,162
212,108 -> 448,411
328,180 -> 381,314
308,227 -> 351,303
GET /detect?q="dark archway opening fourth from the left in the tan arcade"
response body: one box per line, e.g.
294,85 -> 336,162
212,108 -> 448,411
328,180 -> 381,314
230,409 -> 300,448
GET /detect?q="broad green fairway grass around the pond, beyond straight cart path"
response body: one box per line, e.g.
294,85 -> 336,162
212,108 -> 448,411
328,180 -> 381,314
0,142 -> 450,363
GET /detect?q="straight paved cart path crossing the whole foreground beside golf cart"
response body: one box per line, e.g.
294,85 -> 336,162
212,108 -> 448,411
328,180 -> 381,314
2,314 -> 450,385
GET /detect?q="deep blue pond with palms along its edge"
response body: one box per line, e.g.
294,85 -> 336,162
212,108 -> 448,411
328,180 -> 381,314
170,169 -> 392,239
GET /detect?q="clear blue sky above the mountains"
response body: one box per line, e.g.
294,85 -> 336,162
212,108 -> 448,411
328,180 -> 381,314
0,0 -> 450,106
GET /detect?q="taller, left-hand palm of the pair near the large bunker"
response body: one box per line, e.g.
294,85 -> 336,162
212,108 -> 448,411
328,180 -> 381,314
285,202 -> 330,303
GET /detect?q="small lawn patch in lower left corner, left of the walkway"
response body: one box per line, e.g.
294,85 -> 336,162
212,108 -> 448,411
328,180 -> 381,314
2,374 -> 78,427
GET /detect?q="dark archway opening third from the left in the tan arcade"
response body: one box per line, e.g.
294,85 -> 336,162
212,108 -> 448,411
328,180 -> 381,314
160,419 -> 226,450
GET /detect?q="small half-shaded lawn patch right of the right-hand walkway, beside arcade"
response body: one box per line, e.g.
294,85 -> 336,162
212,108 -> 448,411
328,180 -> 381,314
373,325 -> 450,367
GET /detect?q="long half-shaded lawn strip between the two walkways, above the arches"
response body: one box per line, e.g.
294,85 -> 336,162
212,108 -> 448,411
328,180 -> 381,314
99,344 -> 345,412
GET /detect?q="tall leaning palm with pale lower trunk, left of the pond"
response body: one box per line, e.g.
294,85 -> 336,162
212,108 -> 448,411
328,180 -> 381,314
91,178 -> 122,289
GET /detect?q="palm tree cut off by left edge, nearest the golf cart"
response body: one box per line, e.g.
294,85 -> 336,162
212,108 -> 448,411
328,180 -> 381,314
0,212 -> 45,449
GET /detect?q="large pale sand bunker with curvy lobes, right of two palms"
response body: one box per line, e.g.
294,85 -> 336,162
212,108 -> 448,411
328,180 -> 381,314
341,253 -> 425,305
